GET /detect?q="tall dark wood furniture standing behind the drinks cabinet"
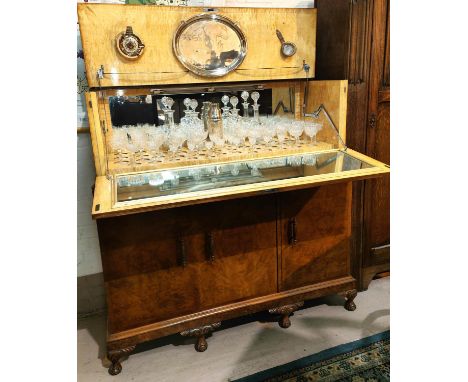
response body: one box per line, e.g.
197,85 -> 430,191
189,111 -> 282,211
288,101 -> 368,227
316,0 -> 390,290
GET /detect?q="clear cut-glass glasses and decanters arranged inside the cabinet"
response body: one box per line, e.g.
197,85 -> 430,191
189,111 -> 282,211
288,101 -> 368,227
110,91 -> 322,162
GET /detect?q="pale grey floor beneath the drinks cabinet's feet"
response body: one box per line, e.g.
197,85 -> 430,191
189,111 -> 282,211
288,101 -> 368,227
78,277 -> 390,382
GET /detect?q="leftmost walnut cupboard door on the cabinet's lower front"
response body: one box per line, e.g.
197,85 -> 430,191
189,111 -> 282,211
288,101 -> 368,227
98,208 -> 201,333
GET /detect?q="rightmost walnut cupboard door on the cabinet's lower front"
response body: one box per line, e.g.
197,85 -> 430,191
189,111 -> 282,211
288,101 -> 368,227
280,182 -> 352,290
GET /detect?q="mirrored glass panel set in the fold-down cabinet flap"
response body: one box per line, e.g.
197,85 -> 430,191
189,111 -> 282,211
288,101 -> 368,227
115,151 -> 375,203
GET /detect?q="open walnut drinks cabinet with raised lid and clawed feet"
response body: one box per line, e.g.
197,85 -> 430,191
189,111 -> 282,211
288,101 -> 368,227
78,4 -> 389,375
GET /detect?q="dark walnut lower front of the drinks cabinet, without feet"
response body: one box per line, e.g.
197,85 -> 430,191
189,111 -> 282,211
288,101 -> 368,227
97,182 -> 355,356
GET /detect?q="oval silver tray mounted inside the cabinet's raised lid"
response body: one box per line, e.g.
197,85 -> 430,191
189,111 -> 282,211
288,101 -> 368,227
173,14 -> 247,77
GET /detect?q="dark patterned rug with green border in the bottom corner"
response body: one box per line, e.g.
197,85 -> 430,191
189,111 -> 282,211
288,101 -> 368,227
233,331 -> 390,382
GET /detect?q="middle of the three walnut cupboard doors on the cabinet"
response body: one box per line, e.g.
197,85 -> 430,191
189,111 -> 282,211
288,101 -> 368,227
196,195 -> 278,308
